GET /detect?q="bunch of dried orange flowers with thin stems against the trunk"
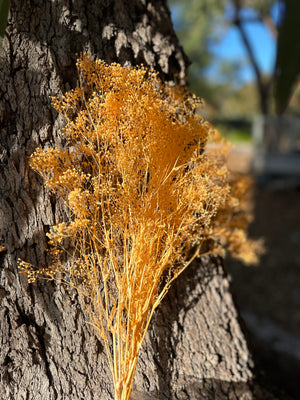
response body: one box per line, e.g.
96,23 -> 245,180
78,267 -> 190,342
20,55 -> 262,400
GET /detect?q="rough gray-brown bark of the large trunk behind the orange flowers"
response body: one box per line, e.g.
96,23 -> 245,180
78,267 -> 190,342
0,0 -> 272,400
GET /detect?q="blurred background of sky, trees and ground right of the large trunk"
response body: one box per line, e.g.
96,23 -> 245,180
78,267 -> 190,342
169,0 -> 300,399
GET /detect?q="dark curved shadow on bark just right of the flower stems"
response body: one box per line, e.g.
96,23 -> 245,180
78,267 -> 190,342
144,257 -> 224,399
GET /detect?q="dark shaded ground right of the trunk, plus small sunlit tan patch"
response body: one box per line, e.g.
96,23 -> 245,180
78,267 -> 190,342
226,144 -> 300,399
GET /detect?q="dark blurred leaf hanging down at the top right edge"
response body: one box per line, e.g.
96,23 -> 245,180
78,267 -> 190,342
275,0 -> 300,114
